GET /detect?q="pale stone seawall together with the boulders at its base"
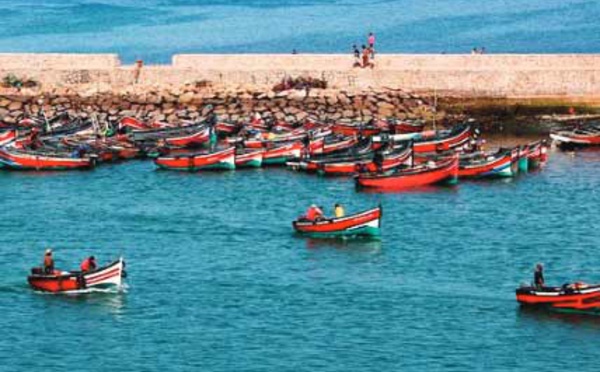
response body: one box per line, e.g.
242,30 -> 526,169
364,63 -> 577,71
0,54 -> 600,123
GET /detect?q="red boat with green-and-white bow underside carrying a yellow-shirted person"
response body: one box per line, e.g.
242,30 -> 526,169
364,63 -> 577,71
292,207 -> 382,237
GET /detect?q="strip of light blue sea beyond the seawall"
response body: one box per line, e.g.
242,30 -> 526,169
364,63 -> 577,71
0,0 -> 600,63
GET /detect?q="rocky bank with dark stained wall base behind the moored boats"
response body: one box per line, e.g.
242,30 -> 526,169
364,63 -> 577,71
0,82 -> 600,134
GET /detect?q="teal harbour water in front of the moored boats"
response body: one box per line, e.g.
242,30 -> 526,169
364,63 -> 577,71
0,147 -> 600,372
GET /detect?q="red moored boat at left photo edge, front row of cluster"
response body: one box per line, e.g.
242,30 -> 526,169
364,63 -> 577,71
0,147 -> 96,171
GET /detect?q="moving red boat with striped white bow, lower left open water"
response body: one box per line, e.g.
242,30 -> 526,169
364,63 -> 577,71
27,257 -> 125,293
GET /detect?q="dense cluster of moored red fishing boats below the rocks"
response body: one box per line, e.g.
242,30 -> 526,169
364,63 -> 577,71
0,115 -> 560,191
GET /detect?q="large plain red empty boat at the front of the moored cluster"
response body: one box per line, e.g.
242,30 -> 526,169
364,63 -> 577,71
356,156 -> 458,190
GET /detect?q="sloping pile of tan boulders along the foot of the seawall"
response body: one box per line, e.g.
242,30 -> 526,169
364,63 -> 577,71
0,84 -> 443,124
